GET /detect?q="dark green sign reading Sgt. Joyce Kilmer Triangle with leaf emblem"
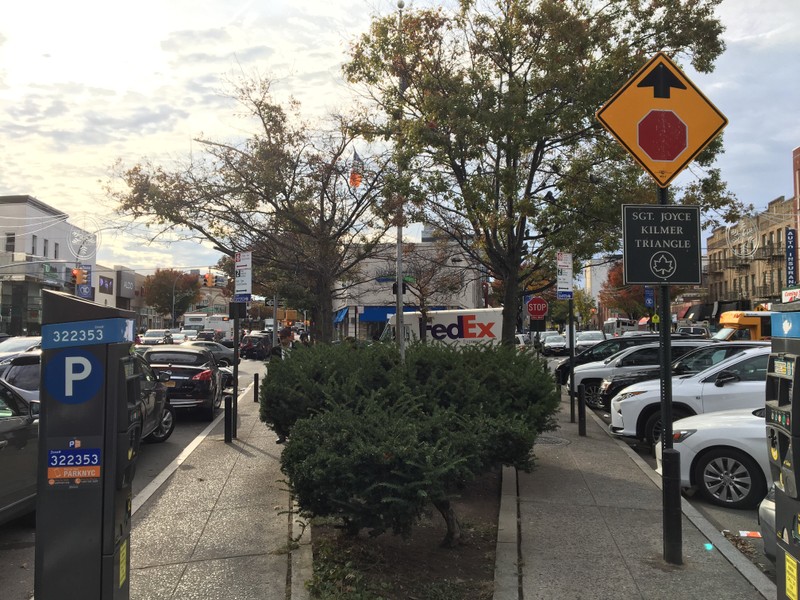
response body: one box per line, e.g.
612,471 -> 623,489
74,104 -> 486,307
622,204 -> 701,285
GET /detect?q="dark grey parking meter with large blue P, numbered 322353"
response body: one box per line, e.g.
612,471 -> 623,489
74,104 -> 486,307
34,290 -> 142,600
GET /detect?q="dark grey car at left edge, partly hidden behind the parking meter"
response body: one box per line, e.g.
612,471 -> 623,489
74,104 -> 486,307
0,381 -> 39,524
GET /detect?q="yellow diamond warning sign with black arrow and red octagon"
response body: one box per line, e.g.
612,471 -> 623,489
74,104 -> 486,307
597,52 -> 728,187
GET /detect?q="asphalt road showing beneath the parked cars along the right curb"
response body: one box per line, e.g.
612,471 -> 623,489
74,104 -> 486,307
548,358 -> 775,582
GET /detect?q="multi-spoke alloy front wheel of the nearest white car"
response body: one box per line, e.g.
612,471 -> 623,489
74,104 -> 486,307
694,448 -> 767,508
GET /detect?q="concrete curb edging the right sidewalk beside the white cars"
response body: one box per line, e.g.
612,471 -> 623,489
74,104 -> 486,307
586,410 -> 778,600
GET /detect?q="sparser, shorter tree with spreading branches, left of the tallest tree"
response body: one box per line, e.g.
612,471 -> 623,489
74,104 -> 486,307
109,80 -> 387,341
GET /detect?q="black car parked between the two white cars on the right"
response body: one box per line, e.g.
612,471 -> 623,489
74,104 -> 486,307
600,341 -> 770,410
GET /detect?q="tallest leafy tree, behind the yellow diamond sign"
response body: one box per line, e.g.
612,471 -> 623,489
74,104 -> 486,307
345,0 -> 741,343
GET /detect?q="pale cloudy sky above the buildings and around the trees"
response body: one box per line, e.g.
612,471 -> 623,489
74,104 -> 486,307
0,0 -> 800,272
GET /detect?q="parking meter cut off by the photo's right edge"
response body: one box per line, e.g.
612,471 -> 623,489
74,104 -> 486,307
764,305 -> 800,598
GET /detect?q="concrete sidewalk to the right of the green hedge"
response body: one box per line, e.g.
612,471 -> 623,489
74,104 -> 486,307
494,398 -> 777,600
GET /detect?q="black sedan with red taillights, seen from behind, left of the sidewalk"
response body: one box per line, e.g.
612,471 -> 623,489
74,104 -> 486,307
143,345 -> 224,421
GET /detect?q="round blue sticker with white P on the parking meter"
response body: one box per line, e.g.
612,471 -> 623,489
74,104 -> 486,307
44,348 -> 105,404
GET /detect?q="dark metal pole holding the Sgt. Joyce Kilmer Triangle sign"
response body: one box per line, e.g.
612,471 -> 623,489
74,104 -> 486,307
658,188 -> 683,565
